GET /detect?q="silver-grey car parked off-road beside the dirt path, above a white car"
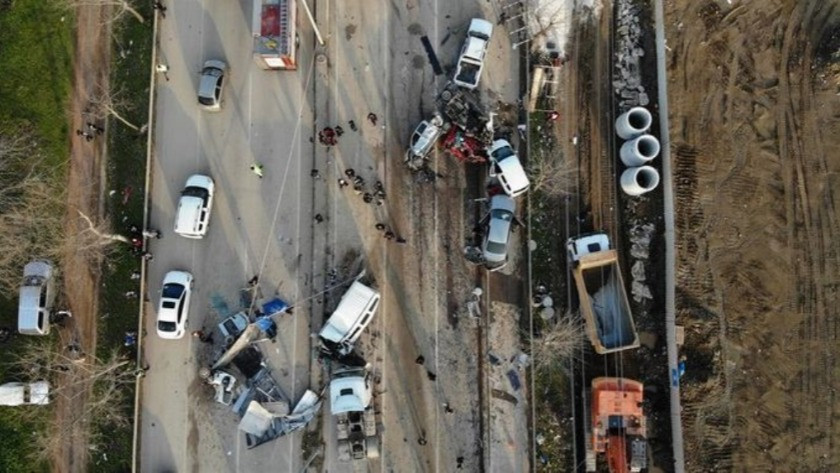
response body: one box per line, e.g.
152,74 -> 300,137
18,261 -> 55,335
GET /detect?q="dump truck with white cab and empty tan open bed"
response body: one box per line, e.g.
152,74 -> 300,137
566,233 -> 639,354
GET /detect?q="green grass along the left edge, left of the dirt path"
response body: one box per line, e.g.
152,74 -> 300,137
0,0 -> 74,473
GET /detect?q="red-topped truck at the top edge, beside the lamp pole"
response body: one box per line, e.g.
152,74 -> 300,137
253,0 -> 298,70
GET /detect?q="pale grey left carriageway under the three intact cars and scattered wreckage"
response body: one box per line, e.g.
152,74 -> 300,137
140,0 -> 314,472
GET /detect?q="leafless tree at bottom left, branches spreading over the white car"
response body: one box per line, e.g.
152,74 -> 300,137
7,340 -> 136,460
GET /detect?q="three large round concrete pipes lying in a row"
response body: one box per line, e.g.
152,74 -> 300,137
615,107 -> 659,196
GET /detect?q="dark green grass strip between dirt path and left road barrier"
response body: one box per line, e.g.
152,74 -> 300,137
90,2 -> 153,472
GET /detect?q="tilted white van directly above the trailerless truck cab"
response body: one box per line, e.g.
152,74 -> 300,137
319,281 -> 380,355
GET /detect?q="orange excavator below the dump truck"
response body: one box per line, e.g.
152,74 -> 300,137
586,378 -> 647,473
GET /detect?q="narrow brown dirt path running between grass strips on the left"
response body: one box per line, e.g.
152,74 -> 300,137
52,6 -> 110,472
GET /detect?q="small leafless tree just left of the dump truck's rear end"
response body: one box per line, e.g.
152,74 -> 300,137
531,313 -> 585,371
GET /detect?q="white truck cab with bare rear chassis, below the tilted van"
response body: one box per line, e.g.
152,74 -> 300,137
330,365 -> 379,462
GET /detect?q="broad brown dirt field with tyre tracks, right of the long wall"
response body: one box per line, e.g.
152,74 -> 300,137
666,0 -> 840,471
